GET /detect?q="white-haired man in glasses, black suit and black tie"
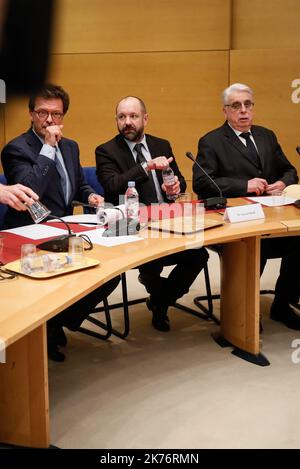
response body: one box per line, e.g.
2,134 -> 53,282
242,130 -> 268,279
193,83 -> 300,330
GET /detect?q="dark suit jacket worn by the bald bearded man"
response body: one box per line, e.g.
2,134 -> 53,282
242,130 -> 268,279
96,135 -> 186,205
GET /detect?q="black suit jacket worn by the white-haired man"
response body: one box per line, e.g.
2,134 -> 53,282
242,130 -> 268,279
193,122 -> 298,198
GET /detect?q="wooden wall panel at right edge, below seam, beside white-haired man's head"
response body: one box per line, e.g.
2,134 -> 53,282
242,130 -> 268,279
230,49 -> 300,175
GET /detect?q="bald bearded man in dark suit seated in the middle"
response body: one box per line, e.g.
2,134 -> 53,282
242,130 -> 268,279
96,96 -> 208,331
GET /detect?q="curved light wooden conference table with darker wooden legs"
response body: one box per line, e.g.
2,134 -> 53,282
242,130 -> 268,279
0,199 -> 300,447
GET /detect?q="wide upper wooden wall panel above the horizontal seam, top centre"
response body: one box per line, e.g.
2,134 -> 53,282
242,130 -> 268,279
53,0 -> 230,54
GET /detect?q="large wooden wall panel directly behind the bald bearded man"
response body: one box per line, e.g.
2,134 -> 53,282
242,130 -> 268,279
51,51 -> 228,183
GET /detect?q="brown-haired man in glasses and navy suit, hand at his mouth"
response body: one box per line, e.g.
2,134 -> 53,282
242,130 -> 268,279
1,85 -> 119,361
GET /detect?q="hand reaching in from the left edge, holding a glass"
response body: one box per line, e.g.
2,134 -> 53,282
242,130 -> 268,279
0,184 -> 39,211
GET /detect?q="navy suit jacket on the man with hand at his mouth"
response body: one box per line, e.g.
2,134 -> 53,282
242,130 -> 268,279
1,130 -> 95,228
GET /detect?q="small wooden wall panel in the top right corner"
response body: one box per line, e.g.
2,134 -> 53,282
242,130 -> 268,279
231,0 -> 300,49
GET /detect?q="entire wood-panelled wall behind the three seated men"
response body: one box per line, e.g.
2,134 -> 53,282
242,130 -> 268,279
0,0 -> 300,185
